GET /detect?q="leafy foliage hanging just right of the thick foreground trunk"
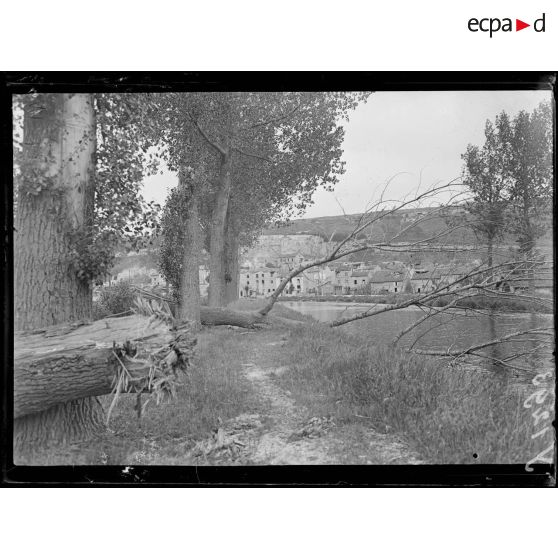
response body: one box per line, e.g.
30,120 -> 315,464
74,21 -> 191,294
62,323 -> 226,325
85,93 -> 160,278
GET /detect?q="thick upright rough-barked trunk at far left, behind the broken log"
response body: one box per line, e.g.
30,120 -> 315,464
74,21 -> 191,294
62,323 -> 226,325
14,94 -> 102,447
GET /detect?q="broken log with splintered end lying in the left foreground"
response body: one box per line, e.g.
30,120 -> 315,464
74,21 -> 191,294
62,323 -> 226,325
14,315 -> 195,418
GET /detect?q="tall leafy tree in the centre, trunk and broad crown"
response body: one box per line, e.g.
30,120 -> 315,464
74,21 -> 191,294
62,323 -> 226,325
155,92 -> 368,316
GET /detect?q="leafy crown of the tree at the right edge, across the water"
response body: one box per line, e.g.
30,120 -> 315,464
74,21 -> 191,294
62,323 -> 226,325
462,103 -> 552,260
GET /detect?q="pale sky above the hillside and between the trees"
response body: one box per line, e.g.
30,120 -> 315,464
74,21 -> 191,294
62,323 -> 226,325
143,91 -> 551,218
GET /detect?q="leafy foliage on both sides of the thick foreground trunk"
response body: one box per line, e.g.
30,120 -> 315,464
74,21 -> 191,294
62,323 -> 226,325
13,93 -> 164,281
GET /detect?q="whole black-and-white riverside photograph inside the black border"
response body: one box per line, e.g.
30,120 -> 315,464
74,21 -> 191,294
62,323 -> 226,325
5,79 -> 555,472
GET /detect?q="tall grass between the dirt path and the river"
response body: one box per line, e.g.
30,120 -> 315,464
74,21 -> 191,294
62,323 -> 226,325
279,324 -> 550,463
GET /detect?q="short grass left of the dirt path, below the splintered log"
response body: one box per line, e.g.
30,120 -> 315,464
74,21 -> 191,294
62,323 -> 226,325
18,328 -> 259,465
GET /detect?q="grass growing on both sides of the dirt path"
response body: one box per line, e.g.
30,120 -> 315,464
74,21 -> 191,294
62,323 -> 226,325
20,300 -> 544,465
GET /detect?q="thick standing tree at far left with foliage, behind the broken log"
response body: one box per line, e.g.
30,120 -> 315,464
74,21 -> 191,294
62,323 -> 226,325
14,94 -> 162,452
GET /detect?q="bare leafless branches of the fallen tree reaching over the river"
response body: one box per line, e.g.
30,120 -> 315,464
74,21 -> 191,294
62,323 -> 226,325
260,175 -> 552,380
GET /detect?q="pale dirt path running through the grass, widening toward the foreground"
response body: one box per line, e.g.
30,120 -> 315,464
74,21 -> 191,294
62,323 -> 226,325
186,334 -> 423,465
